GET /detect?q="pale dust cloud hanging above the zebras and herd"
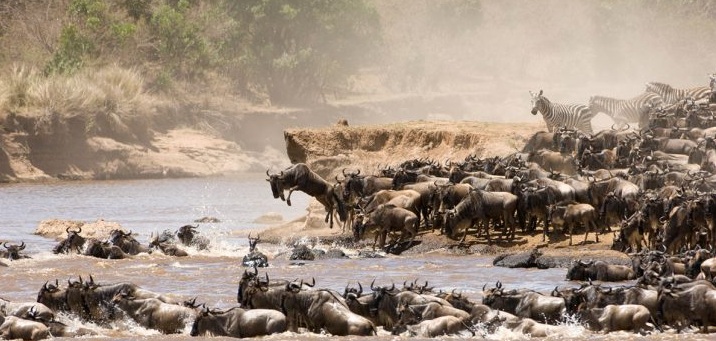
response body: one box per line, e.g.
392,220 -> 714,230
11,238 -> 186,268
374,0 -> 716,124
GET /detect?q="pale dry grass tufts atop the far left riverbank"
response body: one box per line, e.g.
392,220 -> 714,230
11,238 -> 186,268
0,65 -> 151,136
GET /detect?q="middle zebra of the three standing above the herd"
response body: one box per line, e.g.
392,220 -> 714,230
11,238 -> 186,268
589,92 -> 662,128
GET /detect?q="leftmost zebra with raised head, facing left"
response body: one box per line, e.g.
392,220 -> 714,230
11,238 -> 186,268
530,90 -> 595,134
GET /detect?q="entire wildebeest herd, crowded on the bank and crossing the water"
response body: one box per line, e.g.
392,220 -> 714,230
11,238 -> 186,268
0,77 -> 716,340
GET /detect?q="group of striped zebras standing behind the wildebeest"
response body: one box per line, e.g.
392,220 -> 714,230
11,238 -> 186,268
530,73 -> 716,134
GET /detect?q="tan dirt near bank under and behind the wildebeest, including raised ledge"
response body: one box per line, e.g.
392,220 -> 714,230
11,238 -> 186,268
261,121 -> 630,267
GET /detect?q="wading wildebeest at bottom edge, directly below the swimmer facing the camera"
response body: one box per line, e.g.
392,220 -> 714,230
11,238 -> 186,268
190,307 -> 286,338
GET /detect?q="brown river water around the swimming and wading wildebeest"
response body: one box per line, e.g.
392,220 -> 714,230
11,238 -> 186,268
0,174 -> 716,340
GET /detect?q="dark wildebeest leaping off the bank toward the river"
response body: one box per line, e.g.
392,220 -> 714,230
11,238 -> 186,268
266,163 -> 347,228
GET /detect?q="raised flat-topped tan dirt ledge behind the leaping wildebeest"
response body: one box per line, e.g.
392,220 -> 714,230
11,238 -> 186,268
284,121 -> 543,179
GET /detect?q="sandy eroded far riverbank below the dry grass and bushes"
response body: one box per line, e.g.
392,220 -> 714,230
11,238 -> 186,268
0,93 -> 516,182
